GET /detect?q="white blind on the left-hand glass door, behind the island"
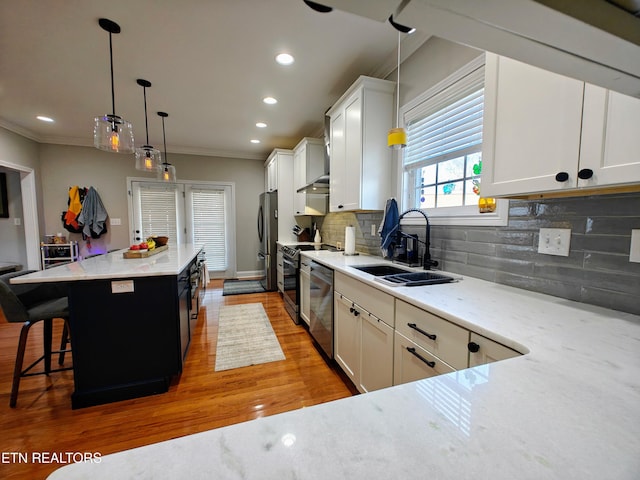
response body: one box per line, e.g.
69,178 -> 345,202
137,183 -> 179,242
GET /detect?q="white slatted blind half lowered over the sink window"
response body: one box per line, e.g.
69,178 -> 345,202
403,68 -> 484,171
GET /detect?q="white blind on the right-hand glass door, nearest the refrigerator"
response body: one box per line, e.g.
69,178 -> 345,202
189,187 -> 228,271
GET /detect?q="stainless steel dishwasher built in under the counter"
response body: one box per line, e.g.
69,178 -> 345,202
309,260 -> 333,358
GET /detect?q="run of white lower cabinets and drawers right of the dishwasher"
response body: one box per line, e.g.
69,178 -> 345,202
330,271 -> 521,393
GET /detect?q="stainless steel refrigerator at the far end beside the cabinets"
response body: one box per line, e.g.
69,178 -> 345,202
258,192 -> 278,291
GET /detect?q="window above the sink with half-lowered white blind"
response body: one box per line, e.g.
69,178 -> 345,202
401,56 -> 508,225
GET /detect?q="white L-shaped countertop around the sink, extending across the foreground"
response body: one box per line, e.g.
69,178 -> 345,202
49,251 -> 640,480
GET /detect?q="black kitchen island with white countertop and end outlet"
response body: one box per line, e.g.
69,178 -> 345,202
12,245 -> 202,408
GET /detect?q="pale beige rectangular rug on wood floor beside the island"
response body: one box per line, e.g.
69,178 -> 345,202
215,303 -> 285,372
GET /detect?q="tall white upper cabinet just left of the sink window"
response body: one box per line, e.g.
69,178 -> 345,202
327,76 -> 395,212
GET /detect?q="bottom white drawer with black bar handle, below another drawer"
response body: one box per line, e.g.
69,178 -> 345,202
393,331 -> 455,385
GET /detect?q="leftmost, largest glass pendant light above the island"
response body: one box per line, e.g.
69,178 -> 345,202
93,18 -> 135,153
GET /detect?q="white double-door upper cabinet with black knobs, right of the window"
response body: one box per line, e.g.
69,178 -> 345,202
481,53 -> 640,197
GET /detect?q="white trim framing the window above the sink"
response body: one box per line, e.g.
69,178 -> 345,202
397,53 -> 509,226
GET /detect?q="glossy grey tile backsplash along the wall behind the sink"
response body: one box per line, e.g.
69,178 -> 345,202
317,193 -> 640,315
